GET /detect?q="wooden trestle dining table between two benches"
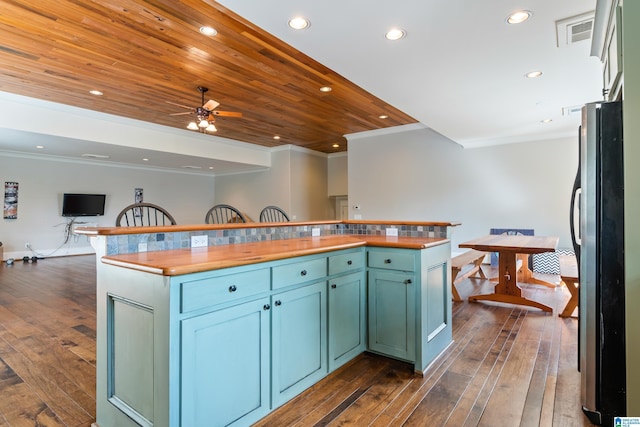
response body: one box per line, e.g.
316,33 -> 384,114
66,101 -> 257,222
459,234 -> 558,312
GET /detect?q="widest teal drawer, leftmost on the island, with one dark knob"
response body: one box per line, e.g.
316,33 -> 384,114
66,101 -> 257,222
181,268 -> 270,313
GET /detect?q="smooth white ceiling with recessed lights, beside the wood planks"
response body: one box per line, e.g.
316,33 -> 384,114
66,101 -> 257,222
0,0 -> 602,174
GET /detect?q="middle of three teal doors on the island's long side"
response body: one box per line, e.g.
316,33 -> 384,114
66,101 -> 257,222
271,281 -> 327,408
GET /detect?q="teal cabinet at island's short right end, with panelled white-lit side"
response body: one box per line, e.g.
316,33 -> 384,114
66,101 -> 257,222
367,242 -> 452,372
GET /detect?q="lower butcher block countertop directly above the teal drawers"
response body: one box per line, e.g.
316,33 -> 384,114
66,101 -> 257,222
102,235 -> 449,276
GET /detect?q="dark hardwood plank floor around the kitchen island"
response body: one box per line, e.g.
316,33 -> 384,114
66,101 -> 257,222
0,256 -> 591,427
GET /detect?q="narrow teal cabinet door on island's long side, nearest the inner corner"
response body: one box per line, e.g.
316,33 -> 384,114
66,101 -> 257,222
329,273 -> 365,371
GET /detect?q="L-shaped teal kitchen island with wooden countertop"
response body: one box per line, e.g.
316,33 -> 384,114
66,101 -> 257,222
80,222 -> 458,427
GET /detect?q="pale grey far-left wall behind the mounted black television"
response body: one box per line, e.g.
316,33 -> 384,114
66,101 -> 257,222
0,154 -> 214,259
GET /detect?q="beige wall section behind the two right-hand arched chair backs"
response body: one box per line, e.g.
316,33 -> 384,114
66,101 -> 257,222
215,147 -> 335,221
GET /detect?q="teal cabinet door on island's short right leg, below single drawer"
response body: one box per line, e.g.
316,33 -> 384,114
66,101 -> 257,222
368,269 -> 416,362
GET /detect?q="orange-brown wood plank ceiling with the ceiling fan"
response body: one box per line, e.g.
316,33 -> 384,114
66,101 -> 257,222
0,0 -> 416,153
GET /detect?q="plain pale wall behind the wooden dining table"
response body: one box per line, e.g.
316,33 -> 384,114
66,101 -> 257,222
348,129 -> 578,252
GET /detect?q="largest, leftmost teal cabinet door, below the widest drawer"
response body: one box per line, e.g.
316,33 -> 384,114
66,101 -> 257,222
181,298 -> 270,426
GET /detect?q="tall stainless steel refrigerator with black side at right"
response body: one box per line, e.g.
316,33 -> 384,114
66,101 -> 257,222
570,102 -> 626,426
